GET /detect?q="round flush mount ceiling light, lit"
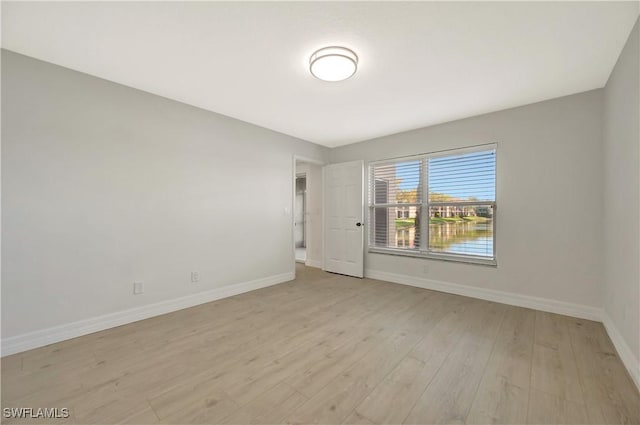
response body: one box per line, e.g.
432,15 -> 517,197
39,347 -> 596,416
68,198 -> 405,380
309,46 -> 358,82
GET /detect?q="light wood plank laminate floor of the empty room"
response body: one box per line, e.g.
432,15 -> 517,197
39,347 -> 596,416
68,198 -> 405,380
2,265 -> 640,424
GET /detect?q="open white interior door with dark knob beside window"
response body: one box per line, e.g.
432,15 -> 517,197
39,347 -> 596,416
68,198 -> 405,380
324,161 -> 365,277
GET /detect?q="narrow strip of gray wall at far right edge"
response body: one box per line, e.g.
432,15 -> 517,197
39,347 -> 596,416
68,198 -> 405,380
602,18 -> 640,364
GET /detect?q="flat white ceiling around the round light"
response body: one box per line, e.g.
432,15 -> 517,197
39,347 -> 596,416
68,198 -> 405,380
2,2 -> 639,147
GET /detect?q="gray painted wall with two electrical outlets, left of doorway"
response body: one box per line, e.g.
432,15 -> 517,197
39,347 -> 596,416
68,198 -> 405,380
2,50 -> 328,338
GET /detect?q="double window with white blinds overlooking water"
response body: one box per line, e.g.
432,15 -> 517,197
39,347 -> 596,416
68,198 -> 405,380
369,145 -> 496,264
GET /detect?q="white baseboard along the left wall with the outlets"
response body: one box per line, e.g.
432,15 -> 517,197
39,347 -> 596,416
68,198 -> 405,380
2,271 -> 294,356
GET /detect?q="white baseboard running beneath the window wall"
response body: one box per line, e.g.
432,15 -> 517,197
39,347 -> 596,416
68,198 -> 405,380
364,270 -> 602,322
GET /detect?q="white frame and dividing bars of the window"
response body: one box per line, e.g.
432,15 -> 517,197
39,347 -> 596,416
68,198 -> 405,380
367,143 -> 498,266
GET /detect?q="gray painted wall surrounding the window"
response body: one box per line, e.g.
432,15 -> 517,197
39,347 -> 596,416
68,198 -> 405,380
331,90 -> 602,307
